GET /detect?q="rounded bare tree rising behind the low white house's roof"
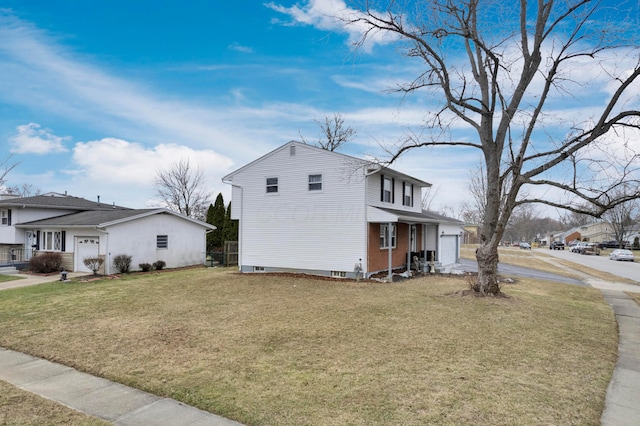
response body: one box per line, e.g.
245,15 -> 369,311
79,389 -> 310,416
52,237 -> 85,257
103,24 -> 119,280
154,159 -> 212,220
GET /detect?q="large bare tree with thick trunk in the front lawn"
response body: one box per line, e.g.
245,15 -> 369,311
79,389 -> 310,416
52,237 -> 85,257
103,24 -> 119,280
339,0 -> 640,295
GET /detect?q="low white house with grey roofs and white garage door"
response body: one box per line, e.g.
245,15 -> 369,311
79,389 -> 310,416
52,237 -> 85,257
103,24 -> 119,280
0,193 -> 215,274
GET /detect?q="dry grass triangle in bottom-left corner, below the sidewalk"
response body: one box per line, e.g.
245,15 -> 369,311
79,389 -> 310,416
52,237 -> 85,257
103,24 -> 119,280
0,381 -> 110,426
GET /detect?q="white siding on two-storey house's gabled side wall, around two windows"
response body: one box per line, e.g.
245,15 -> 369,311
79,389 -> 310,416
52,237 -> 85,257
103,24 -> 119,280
232,145 -> 366,273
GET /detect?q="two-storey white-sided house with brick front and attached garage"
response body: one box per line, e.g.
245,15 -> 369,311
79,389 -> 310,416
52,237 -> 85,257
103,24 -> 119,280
223,141 -> 462,277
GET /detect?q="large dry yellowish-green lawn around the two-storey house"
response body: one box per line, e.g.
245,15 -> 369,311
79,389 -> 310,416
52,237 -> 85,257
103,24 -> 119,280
0,269 -> 617,425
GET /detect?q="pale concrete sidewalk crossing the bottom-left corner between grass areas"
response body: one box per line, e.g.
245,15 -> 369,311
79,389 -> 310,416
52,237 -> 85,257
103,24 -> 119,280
0,348 -> 240,426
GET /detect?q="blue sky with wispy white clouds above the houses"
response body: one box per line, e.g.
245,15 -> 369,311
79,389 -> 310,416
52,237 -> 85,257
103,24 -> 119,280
0,0 -> 636,216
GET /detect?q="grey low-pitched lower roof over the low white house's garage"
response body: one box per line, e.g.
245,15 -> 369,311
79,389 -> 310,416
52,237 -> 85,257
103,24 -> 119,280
16,209 -> 216,229
